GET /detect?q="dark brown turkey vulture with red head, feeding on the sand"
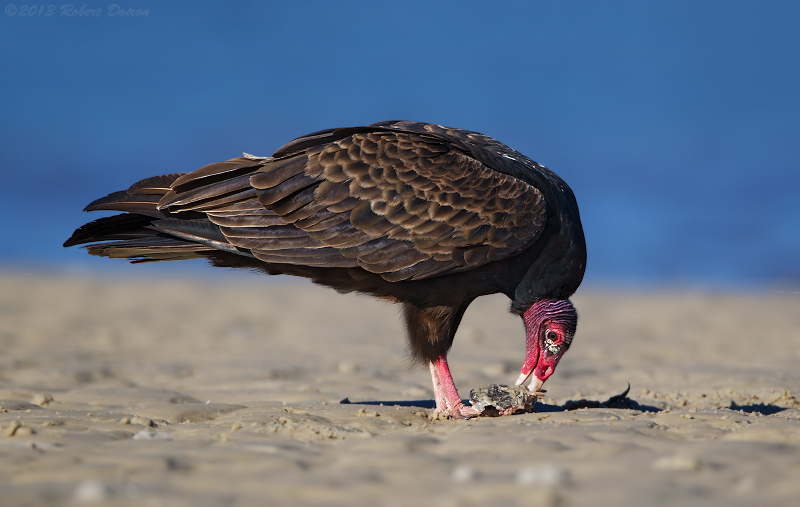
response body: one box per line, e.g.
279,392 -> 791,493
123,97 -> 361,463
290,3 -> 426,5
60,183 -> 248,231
64,121 -> 586,418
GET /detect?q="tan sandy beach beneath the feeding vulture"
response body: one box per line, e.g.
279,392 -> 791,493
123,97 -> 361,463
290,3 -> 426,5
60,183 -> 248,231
0,272 -> 800,506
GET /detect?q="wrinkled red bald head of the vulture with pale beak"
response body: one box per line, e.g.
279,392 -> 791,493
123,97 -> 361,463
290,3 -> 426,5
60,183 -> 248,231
517,299 -> 578,391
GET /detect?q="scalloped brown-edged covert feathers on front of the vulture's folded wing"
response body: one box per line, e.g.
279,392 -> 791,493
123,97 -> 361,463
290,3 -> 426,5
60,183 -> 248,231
288,132 -> 544,280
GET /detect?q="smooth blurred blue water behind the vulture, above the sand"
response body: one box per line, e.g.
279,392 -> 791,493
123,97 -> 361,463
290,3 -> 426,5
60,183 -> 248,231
0,1 -> 800,288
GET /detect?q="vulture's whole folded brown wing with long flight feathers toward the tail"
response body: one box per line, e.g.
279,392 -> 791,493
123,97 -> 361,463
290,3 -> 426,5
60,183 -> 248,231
70,127 -> 545,281
